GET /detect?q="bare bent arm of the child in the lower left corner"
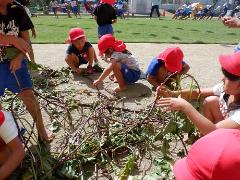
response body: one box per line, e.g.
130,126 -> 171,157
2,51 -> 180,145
0,137 -> 25,179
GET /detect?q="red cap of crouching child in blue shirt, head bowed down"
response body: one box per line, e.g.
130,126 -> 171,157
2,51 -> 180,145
157,47 -> 183,72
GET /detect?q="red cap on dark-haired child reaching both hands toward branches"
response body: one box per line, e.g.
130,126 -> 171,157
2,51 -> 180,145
219,52 -> 240,77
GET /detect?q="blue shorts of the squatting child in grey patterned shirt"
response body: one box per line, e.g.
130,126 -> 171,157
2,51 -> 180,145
121,64 -> 141,83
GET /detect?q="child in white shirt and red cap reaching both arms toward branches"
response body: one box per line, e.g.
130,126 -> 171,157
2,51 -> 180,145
157,52 -> 240,134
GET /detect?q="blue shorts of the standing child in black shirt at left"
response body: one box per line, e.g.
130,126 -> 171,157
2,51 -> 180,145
0,60 -> 32,96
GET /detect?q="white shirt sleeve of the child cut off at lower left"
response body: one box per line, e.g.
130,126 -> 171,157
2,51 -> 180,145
0,110 -> 18,144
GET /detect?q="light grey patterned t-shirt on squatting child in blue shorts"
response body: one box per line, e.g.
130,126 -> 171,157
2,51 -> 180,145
111,51 -> 140,71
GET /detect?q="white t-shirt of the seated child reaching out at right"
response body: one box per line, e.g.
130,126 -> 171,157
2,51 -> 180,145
213,83 -> 240,124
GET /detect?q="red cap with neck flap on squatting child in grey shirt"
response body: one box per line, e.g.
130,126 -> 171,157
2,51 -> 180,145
98,34 -> 126,56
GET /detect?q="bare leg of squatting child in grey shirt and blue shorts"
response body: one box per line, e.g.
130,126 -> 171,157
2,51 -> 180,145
113,61 -> 126,92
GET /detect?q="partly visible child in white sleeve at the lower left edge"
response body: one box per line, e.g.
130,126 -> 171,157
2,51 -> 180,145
0,107 -> 25,179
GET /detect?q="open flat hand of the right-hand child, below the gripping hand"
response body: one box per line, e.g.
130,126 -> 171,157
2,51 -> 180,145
156,97 -> 189,111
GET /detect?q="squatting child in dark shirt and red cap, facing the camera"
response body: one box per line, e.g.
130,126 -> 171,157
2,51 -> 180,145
65,28 -> 97,74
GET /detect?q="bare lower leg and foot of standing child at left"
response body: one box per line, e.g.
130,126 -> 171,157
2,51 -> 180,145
18,89 -> 54,142
